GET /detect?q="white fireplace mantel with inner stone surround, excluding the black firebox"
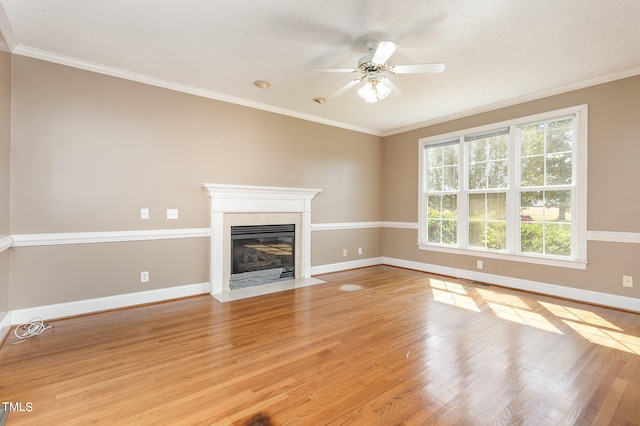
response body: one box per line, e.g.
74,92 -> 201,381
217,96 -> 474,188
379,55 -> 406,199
203,183 -> 321,295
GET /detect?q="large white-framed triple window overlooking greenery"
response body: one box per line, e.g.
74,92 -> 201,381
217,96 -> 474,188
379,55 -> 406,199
419,105 -> 587,268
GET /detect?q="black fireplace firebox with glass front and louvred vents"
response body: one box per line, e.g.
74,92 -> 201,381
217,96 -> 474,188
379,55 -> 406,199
229,224 -> 295,290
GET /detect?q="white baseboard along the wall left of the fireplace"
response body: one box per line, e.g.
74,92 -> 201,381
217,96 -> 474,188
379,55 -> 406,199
10,282 -> 211,325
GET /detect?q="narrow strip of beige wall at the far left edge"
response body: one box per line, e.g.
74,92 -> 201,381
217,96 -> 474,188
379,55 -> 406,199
0,46 -> 11,320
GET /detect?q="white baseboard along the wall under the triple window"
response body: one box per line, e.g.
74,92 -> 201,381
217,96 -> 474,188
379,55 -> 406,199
383,257 -> 640,312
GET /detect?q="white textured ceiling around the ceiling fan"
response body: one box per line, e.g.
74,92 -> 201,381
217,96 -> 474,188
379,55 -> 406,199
0,0 -> 640,135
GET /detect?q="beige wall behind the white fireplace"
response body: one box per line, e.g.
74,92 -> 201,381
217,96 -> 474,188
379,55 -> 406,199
11,56 -> 382,309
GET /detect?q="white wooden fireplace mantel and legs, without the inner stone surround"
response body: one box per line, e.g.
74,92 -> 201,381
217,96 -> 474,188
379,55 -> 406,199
203,183 -> 322,295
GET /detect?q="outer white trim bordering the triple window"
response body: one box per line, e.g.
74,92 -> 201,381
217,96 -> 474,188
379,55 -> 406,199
418,104 -> 588,269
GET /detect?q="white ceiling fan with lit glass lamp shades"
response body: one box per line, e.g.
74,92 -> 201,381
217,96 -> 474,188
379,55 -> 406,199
317,40 -> 445,103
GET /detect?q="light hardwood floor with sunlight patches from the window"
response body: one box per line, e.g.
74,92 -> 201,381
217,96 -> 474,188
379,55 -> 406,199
0,266 -> 640,426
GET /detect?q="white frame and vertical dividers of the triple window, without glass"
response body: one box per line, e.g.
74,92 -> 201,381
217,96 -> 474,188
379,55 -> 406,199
418,105 -> 588,269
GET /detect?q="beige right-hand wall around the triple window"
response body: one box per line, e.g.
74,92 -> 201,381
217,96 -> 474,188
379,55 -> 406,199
383,76 -> 640,298
